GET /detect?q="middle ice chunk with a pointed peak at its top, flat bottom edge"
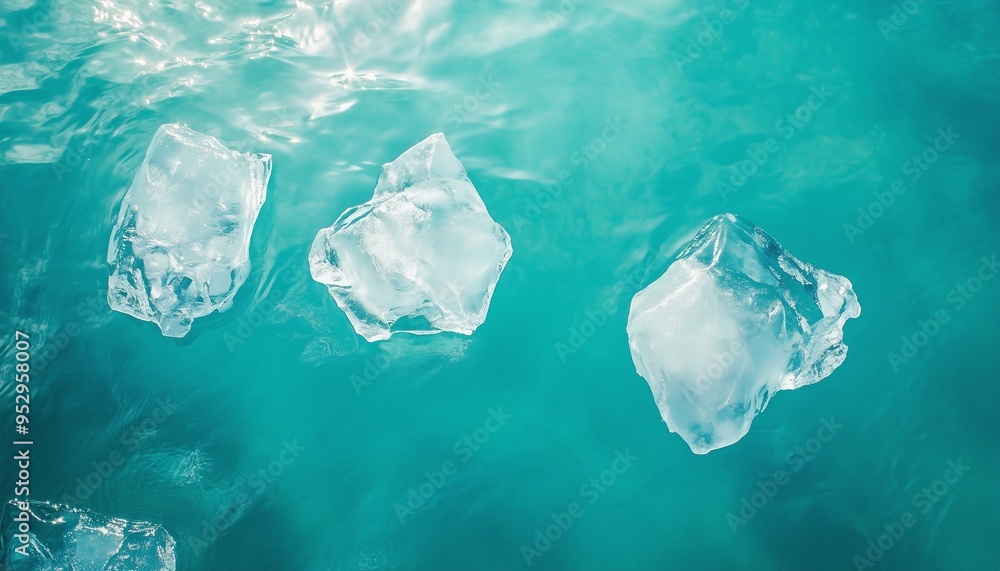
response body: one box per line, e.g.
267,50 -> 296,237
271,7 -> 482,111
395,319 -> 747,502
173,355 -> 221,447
309,133 -> 513,341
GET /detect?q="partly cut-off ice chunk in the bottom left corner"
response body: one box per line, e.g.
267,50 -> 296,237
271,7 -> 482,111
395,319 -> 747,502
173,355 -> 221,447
0,501 -> 177,571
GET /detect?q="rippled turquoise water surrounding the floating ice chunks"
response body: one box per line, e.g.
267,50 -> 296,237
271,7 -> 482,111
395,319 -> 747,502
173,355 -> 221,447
0,0 -> 1000,570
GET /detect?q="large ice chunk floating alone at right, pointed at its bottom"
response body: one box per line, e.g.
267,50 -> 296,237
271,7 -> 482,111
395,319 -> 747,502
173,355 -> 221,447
627,214 -> 861,454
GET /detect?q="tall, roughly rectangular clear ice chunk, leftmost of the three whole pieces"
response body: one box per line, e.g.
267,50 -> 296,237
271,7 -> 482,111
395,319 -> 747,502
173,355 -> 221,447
108,124 -> 271,337
